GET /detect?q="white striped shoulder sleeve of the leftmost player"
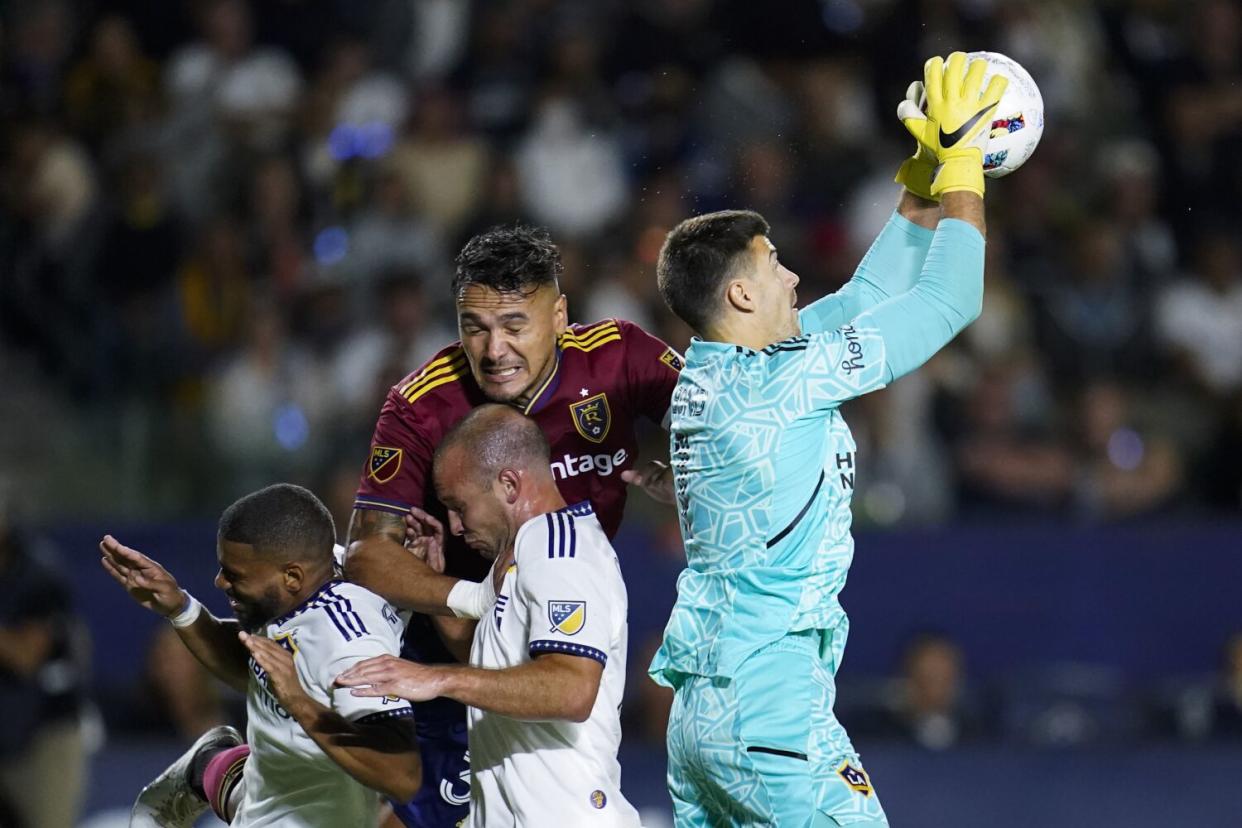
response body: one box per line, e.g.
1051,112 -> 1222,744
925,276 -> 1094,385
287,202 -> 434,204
308,585 -> 414,722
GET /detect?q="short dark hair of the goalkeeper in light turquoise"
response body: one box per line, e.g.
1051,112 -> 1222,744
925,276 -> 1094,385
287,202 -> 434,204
656,210 -> 770,333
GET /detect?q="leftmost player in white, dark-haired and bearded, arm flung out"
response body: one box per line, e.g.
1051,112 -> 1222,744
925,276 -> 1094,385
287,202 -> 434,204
99,484 -> 422,828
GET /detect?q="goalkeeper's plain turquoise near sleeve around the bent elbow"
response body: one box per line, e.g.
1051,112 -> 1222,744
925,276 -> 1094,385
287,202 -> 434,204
854,218 -> 985,382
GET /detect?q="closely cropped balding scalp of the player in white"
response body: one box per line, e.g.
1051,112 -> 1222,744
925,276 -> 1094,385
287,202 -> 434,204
435,403 -> 551,489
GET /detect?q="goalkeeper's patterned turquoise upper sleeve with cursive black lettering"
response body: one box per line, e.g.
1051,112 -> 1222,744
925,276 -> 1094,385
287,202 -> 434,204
763,324 -> 888,416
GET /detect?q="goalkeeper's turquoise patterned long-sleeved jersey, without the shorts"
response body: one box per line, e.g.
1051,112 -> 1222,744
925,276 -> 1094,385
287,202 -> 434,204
651,215 -> 984,686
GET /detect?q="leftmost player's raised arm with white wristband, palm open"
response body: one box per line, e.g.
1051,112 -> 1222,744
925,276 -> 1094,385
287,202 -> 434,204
99,535 -> 248,693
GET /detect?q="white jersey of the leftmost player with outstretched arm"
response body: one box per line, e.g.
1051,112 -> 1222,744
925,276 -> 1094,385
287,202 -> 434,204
231,580 -> 414,828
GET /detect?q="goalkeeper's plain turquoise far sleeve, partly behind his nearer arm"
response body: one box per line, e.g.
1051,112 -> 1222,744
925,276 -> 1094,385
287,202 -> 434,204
799,210 -> 935,334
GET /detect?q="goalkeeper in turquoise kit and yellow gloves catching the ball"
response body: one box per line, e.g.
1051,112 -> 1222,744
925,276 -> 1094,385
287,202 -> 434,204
651,53 -> 1005,828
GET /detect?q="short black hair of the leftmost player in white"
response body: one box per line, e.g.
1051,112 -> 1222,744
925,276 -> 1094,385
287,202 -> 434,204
217,483 -> 337,564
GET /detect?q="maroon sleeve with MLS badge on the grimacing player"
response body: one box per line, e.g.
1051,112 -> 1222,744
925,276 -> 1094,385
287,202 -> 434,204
354,389 -> 438,515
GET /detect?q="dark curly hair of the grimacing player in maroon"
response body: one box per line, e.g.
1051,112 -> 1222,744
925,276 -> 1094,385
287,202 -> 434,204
452,225 -> 565,297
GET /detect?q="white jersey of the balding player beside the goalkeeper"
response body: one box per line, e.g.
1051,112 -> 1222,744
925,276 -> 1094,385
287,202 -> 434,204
468,503 -> 638,828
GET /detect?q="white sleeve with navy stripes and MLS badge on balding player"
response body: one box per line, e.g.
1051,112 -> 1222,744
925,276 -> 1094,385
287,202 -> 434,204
517,511 -> 620,665
